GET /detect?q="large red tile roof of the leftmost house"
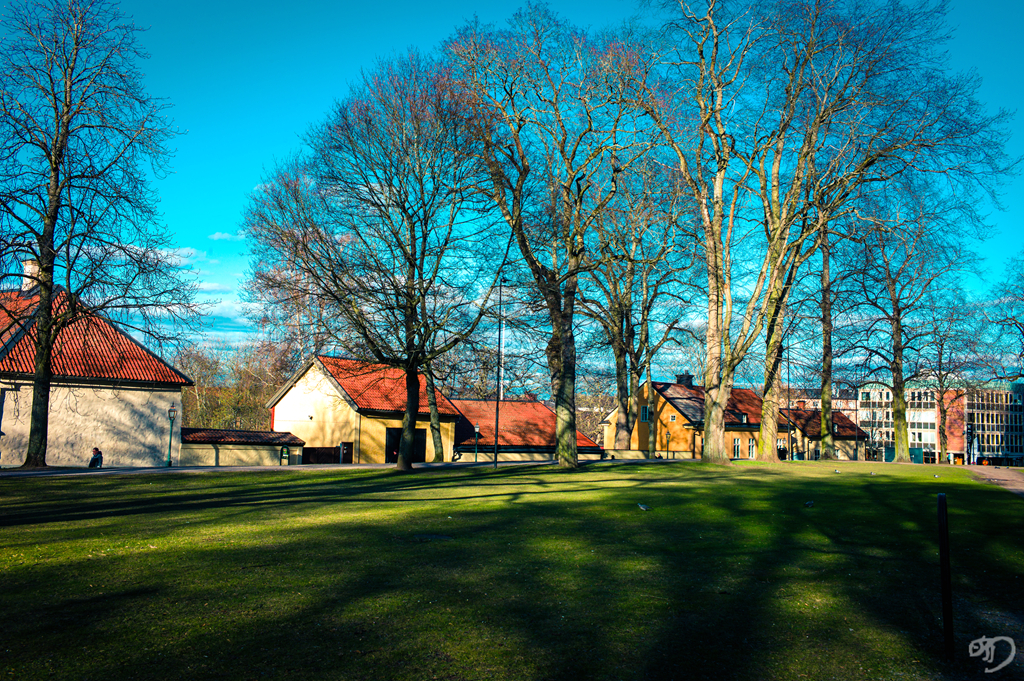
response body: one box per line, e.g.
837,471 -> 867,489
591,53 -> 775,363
0,290 -> 191,386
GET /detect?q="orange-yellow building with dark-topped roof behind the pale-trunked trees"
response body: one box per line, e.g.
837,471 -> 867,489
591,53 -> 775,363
602,374 -> 788,459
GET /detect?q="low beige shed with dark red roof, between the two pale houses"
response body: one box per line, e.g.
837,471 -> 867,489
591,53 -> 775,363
180,428 -> 305,466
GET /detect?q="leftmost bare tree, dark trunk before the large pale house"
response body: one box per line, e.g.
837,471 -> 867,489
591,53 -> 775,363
0,0 -> 197,467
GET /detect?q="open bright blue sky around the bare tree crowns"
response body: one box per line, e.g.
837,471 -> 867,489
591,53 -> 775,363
108,0 -> 1024,340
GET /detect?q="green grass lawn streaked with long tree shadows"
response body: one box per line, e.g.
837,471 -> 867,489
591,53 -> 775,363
0,462 -> 1024,681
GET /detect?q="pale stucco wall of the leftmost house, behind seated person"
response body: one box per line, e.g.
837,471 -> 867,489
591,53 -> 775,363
0,384 -> 181,466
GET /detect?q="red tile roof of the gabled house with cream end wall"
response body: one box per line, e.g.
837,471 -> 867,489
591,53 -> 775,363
316,355 -> 459,416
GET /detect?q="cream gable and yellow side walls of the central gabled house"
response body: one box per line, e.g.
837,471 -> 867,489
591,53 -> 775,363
271,364 -> 455,464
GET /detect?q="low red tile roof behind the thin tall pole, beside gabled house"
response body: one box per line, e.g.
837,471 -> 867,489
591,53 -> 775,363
452,399 -> 599,448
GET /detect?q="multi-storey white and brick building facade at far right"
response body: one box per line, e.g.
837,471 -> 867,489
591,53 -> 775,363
857,382 -> 1024,465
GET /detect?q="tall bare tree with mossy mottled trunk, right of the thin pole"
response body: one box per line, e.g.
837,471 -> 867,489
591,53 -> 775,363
446,5 -> 648,467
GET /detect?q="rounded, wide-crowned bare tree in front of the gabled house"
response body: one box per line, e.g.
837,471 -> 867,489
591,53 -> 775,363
245,54 -> 507,470
